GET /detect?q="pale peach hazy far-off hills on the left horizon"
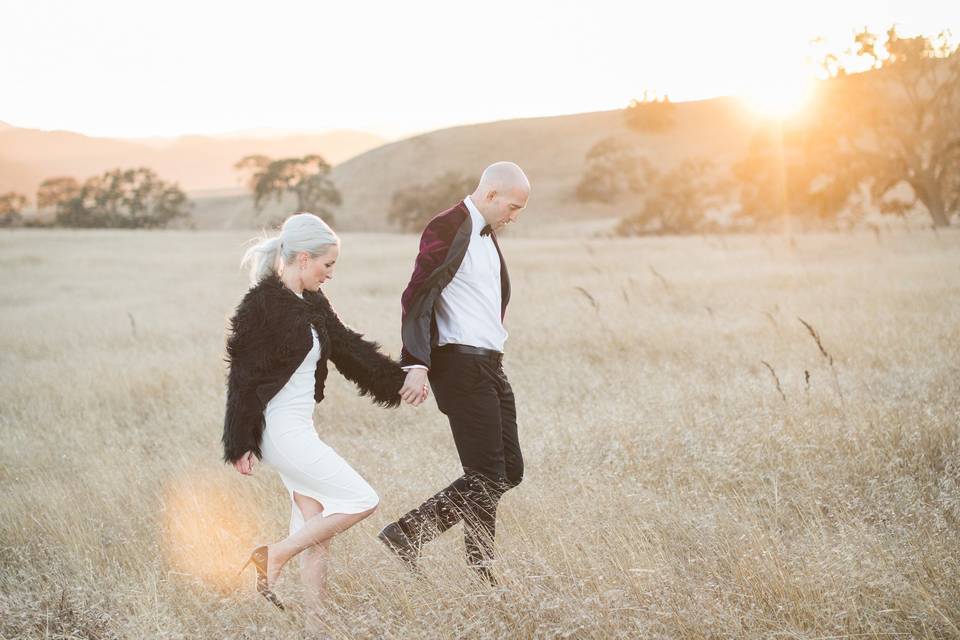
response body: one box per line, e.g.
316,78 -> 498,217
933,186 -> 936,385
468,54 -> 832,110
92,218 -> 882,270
0,123 -> 383,198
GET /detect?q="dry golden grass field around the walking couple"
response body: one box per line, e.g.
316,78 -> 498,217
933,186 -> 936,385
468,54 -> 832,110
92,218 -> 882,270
0,230 -> 960,639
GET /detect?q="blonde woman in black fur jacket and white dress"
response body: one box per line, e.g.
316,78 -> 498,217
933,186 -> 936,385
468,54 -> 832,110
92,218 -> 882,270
223,213 -> 426,609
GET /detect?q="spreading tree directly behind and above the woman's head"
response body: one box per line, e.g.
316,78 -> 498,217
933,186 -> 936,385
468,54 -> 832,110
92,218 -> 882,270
234,154 -> 342,222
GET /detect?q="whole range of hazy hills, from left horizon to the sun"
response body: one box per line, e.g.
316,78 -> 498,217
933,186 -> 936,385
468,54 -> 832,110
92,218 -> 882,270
0,98 -> 757,235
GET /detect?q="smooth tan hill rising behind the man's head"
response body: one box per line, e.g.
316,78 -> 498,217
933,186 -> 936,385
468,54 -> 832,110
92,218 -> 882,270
194,98 -> 756,235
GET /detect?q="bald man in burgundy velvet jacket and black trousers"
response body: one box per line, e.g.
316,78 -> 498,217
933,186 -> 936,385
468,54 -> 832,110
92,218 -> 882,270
379,162 -> 530,584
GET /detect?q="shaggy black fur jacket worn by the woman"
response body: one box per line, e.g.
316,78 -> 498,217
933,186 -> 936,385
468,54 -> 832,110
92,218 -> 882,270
223,275 -> 404,462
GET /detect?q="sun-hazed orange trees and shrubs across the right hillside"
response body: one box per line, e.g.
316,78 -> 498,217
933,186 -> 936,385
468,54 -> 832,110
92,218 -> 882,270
576,28 -> 960,235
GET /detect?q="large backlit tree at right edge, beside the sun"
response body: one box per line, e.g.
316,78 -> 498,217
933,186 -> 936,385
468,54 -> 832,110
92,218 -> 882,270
812,27 -> 960,227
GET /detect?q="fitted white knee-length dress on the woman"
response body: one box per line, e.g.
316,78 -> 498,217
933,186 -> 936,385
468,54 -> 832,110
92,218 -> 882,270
260,320 -> 380,534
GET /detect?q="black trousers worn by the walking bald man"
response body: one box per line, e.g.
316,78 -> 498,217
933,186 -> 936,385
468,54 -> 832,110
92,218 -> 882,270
398,349 -> 523,578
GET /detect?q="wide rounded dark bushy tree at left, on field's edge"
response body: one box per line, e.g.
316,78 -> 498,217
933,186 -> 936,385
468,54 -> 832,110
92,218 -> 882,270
56,167 -> 190,229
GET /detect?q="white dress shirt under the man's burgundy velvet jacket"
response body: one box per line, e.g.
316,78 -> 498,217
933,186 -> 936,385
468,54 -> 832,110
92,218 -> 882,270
436,196 -> 507,353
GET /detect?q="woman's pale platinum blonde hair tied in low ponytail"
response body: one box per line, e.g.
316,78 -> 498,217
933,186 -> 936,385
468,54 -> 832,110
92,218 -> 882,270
240,213 -> 340,284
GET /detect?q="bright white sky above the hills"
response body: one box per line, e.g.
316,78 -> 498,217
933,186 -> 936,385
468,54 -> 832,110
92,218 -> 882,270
0,0 -> 960,138
